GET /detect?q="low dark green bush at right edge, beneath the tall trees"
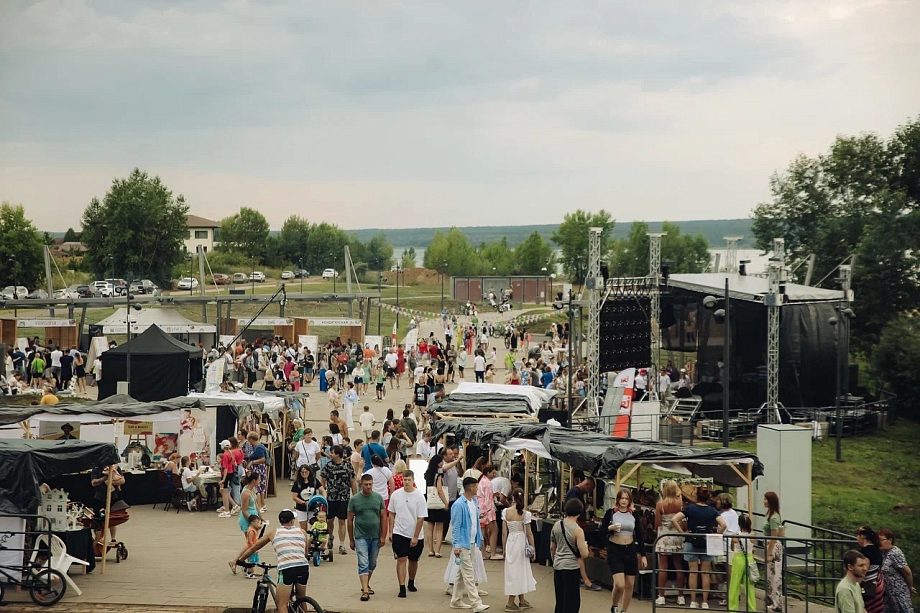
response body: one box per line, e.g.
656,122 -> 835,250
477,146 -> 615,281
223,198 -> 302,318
870,314 -> 920,419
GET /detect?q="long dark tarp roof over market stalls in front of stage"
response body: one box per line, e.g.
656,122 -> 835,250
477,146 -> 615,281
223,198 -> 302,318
431,420 -> 763,487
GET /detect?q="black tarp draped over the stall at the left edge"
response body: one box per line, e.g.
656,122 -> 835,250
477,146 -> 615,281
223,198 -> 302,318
0,439 -> 119,514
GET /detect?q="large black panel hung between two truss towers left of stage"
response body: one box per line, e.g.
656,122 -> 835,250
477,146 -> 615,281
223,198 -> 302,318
598,296 -> 652,372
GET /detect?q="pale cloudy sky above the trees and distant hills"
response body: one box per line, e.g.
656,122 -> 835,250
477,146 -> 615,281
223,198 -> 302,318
0,0 -> 920,231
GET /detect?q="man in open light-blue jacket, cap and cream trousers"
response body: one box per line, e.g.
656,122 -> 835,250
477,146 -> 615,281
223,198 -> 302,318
450,477 -> 489,613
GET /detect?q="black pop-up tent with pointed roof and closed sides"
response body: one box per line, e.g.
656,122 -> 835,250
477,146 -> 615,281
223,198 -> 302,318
99,325 -> 203,402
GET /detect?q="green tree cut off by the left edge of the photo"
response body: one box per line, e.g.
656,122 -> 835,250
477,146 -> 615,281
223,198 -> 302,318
0,201 -> 45,286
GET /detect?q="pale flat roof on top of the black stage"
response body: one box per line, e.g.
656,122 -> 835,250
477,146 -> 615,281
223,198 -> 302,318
668,272 -> 843,302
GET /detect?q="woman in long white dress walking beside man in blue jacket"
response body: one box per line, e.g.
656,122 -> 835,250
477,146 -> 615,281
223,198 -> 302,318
502,489 -> 537,611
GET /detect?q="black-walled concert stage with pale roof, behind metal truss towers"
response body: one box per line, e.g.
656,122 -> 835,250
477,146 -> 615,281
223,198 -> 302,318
660,273 -> 844,411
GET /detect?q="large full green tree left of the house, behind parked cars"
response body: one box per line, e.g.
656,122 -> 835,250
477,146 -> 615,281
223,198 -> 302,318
81,168 -> 188,285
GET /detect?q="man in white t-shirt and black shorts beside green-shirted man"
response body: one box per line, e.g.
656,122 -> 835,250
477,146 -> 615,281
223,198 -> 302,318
388,470 -> 428,598
